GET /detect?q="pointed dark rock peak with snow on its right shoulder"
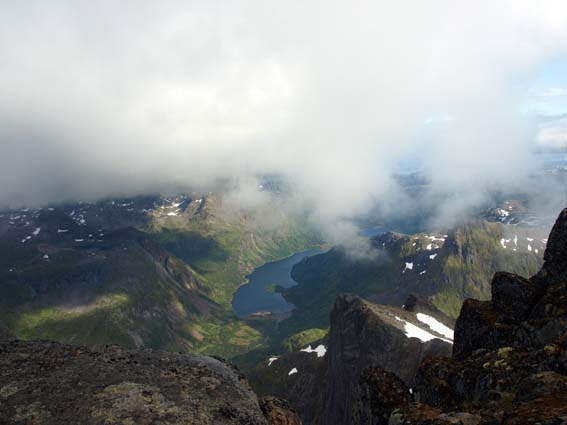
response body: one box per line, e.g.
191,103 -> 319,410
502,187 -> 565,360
319,295 -> 451,424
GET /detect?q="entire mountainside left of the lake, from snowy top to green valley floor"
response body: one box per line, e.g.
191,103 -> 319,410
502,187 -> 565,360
0,194 -> 324,357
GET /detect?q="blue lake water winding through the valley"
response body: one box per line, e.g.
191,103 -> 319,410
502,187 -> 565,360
232,227 -> 388,318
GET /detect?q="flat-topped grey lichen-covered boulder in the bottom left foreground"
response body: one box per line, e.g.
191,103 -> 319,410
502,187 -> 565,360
0,340 -> 276,425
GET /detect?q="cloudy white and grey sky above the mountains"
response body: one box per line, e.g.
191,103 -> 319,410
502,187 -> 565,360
0,0 -> 567,242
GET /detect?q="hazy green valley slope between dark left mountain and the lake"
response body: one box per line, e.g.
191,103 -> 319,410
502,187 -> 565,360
149,203 -> 322,309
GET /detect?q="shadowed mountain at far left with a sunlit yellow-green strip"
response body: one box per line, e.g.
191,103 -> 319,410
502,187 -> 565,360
1,238 -> 211,351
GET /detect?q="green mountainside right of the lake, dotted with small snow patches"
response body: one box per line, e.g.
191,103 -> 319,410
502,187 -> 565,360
281,220 -> 547,342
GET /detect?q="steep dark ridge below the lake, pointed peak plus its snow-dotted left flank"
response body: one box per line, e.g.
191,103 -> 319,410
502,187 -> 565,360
249,295 -> 453,424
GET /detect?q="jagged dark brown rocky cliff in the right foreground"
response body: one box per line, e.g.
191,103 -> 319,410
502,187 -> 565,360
364,209 -> 567,425
